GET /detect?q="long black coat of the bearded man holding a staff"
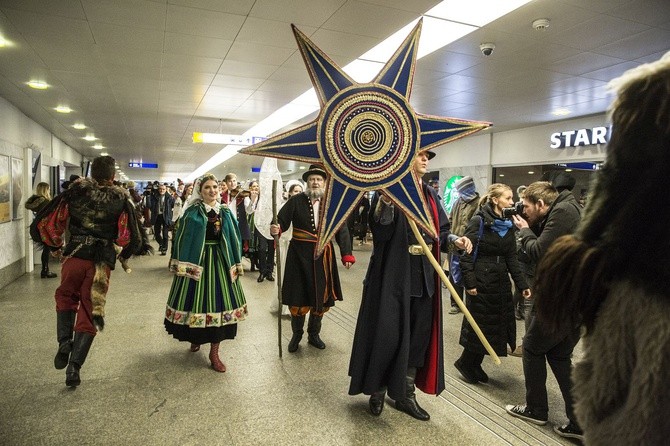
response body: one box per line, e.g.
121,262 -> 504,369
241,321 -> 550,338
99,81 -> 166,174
277,193 -> 351,311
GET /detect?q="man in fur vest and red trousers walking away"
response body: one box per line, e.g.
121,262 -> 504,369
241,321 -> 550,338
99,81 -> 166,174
30,156 -> 151,387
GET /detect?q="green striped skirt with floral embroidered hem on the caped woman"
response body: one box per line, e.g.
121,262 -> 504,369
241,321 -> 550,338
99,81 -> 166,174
164,240 -> 247,344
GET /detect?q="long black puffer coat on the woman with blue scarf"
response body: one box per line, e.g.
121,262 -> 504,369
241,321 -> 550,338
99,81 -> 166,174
459,204 -> 528,356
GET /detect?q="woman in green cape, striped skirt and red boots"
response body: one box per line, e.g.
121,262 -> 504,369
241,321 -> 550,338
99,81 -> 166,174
164,174 -> 247,372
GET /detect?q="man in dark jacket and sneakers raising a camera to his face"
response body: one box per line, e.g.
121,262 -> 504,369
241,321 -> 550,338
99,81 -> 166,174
505,181 -> 582,439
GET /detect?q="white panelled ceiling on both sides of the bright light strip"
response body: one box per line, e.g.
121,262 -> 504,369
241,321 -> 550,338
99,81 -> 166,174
0,0 -> 670,180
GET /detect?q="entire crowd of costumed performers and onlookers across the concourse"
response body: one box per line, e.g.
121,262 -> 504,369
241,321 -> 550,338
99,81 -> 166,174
26,53 -> 670,444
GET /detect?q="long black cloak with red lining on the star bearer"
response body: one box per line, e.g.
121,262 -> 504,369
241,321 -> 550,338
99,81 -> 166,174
349,184 -> 449,400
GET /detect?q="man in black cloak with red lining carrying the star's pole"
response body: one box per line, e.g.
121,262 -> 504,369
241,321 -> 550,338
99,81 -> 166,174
349,150 -> 472,421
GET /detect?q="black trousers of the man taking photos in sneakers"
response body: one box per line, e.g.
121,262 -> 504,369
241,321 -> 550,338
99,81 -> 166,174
523,317 -> 579,423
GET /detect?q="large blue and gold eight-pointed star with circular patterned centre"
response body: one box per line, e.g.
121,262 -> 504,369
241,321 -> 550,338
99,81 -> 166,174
241,20 -> 491,256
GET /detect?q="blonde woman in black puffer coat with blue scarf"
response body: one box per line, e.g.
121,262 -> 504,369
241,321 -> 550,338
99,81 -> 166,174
454,183 -> 530,384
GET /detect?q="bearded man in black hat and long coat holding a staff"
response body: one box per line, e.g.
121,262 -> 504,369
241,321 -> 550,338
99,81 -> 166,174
270,165 -> 356,353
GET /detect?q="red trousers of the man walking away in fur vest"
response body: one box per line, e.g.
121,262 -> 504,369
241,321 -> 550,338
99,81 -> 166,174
55,257 -> 110,335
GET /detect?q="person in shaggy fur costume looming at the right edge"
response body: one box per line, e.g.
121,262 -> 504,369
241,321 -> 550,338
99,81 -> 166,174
534,52 -> 670,446
